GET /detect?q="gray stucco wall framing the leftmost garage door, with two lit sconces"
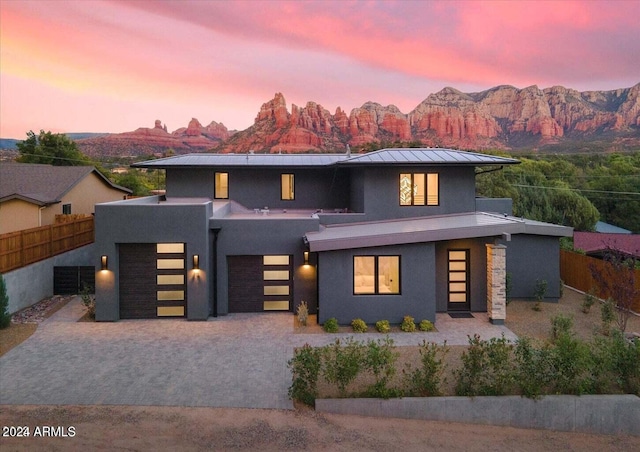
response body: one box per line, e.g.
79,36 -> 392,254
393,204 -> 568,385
93,197 -> 212,321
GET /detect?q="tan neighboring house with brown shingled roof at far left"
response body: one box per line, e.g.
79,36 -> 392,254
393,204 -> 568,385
0,162 -> 131,234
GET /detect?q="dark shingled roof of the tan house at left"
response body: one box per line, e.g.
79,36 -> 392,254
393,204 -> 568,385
0,163 -> 131,206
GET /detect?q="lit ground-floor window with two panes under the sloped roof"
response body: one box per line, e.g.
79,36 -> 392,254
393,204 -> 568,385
353,256 -> 400,295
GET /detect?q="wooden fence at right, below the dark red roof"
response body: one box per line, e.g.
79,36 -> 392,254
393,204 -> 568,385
560,250 -> 640,312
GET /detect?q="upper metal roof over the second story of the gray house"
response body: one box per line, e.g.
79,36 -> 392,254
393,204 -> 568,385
131,148 -> 520,168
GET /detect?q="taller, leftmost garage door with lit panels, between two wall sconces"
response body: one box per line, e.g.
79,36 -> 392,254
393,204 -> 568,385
119,243 -> 186,319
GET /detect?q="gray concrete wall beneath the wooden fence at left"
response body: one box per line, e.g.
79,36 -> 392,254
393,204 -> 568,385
2,244 -> 95,314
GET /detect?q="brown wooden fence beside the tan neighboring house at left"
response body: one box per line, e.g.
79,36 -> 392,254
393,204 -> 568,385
0,217 -> 94,273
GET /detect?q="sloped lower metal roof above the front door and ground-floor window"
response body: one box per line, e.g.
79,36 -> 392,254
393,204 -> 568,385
305,212 -> 573,251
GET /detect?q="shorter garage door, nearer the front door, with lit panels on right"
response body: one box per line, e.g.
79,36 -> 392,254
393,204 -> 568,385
227,255 -> 293,312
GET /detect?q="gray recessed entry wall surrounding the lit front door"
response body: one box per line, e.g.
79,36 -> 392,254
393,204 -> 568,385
436,237 -> 494,312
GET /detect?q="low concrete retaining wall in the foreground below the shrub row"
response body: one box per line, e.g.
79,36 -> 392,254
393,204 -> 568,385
316,394 -> 640,436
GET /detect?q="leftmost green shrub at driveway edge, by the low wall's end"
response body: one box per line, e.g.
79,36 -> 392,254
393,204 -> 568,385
287,344 -> 321,406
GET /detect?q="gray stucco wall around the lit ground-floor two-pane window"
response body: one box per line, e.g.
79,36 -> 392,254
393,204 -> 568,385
318,243 -> 436,324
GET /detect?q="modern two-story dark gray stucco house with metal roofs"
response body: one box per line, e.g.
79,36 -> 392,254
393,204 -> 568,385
96,148 -> 572,324
